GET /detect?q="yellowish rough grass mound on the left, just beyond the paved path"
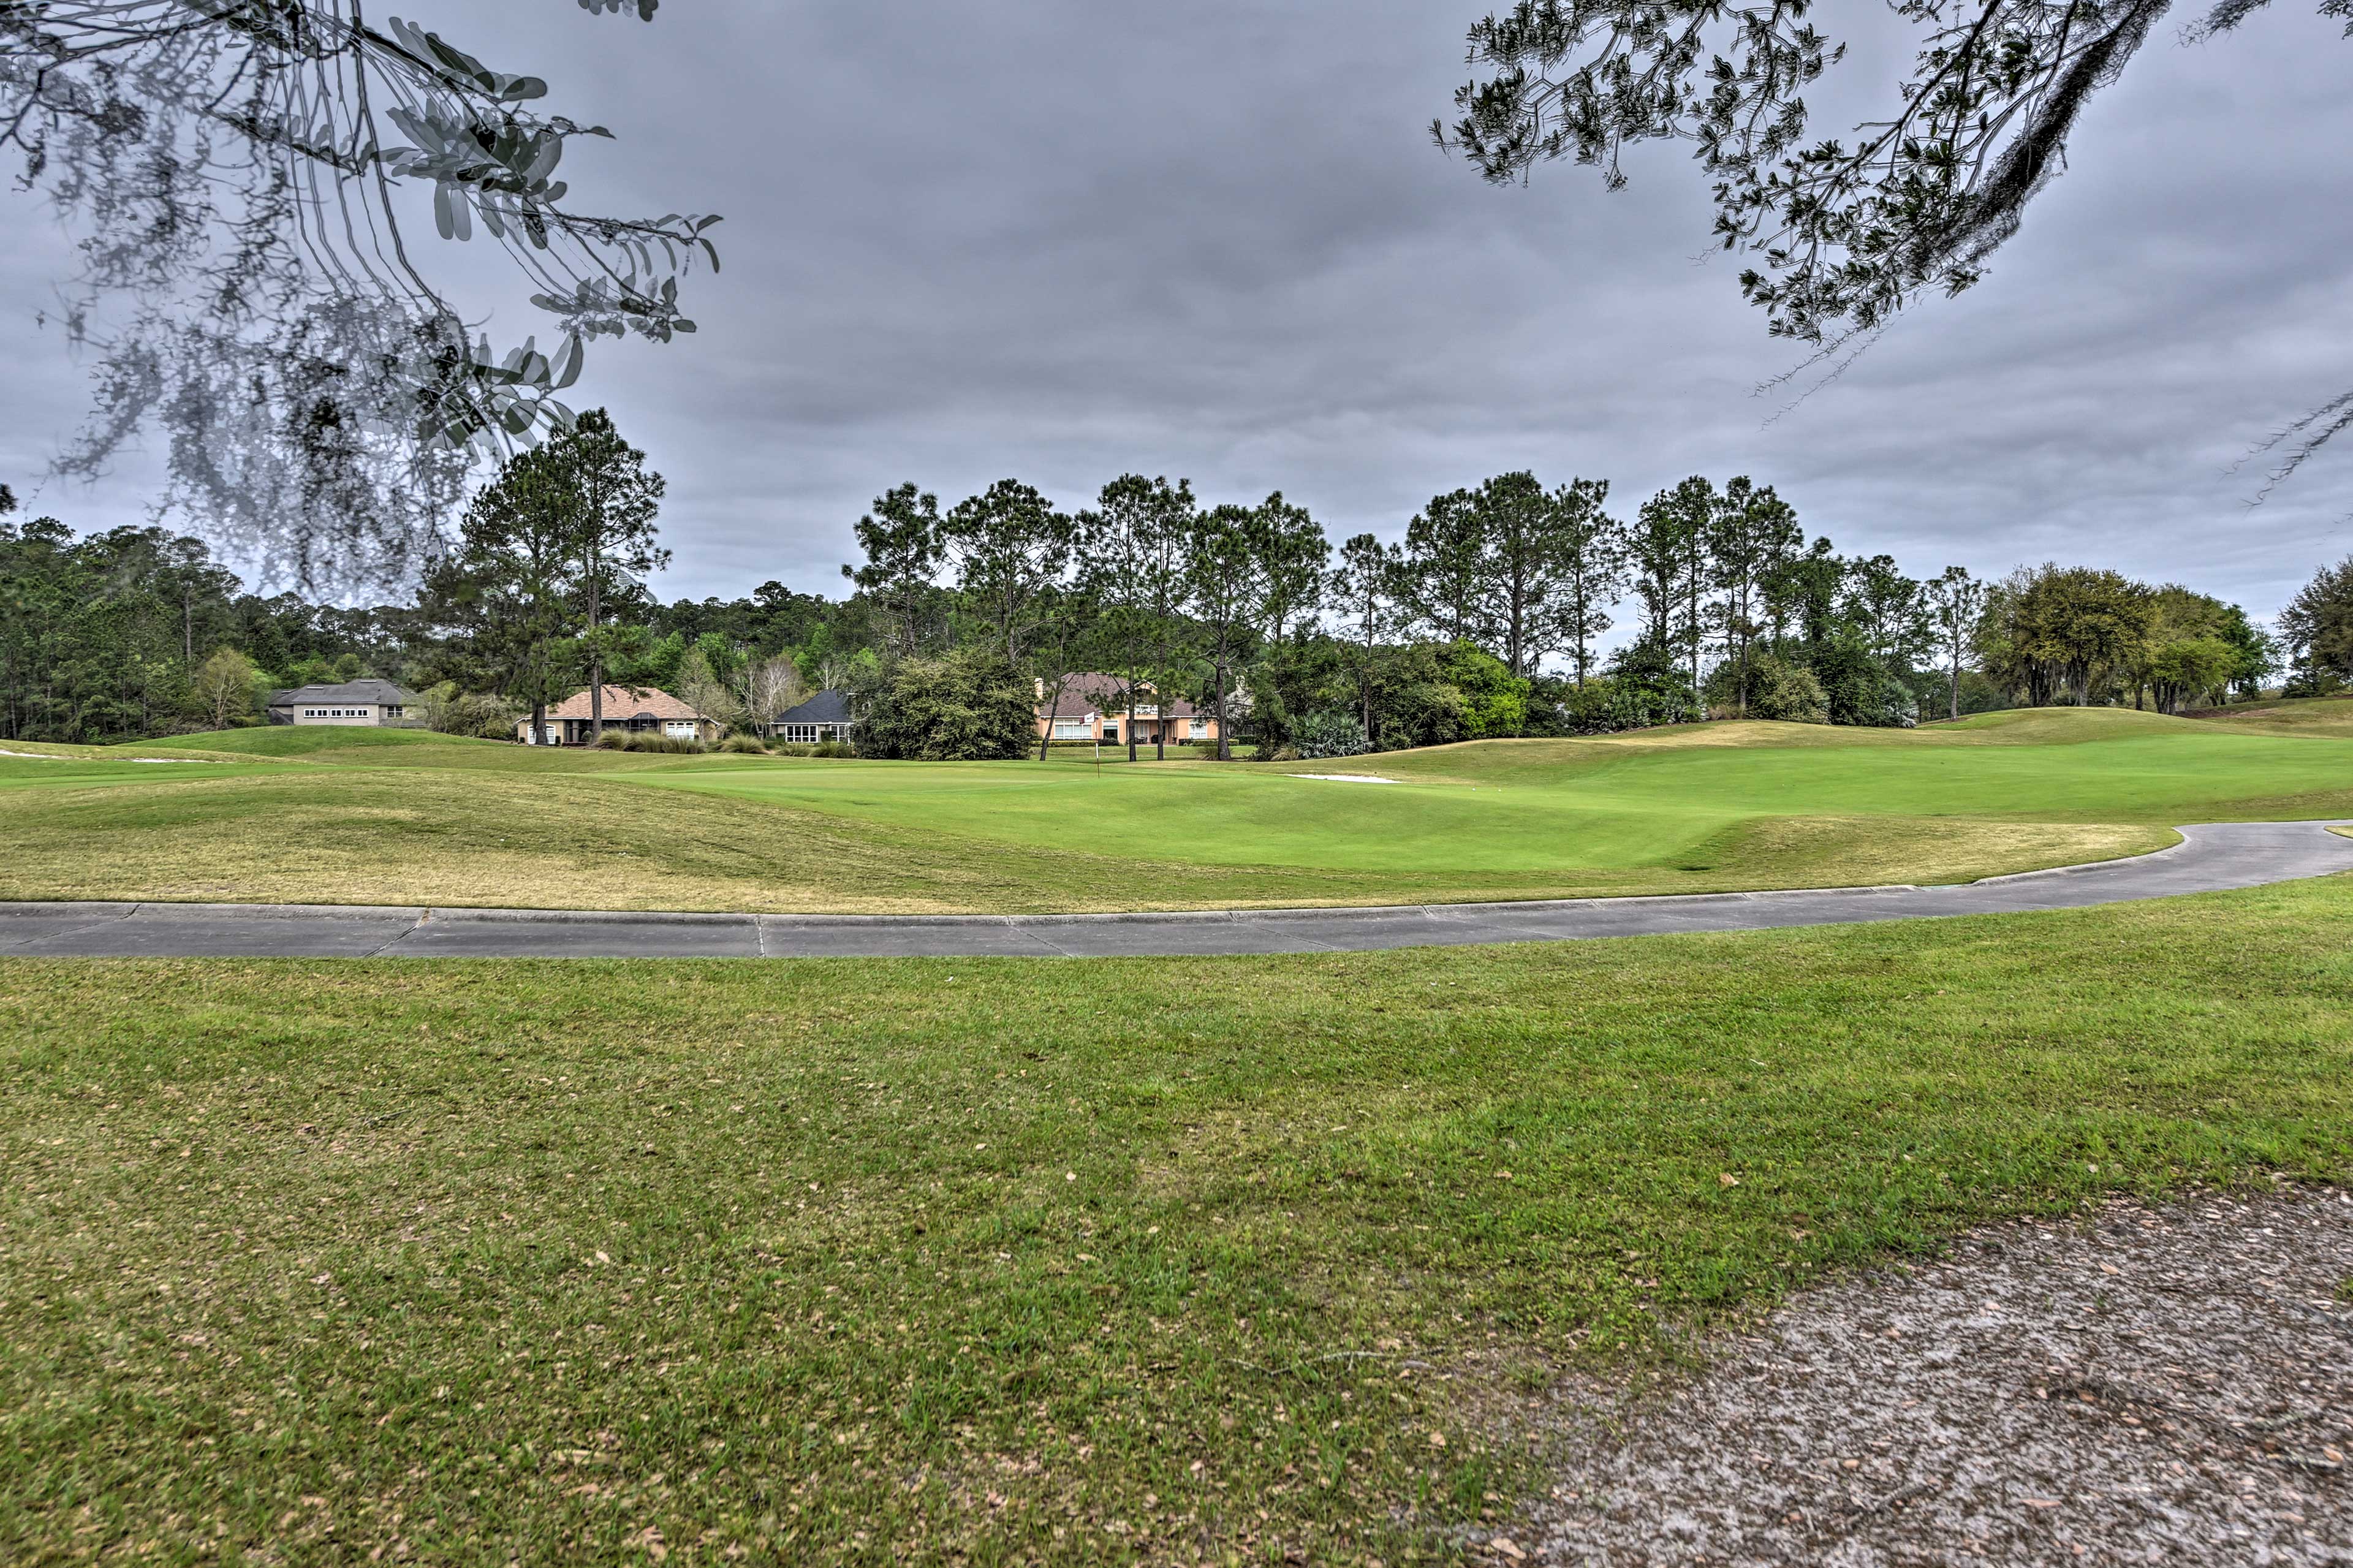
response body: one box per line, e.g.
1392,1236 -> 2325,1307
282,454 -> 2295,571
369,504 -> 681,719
0,746 -> 1383,914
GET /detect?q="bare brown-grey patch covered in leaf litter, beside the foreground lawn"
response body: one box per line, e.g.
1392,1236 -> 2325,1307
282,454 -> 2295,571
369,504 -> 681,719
1506,1191 -> 2353,1566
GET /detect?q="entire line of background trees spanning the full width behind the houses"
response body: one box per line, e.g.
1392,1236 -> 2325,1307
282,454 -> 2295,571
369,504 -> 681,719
0,445 -> 2353,756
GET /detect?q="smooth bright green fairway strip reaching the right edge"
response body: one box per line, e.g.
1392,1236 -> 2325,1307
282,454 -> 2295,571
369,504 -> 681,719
642,711 -> 2353,874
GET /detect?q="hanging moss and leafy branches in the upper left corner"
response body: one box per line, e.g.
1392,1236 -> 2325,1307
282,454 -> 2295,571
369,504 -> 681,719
0,0 -> 718,593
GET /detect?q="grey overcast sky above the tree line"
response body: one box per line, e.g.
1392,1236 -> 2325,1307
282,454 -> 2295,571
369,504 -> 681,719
0,0 -> 2353,615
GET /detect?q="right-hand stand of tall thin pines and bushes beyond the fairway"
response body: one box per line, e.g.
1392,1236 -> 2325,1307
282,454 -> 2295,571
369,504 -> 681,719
843,471 -> 2280,756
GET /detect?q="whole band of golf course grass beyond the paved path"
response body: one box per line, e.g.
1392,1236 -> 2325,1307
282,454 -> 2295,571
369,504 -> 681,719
0,704 -> 2353,914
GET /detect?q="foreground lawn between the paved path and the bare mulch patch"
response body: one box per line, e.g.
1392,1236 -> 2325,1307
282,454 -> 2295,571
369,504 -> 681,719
0,878 -> 2353,1563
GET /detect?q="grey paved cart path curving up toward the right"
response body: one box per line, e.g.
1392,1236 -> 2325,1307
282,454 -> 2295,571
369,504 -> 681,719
0,822 -> 2353,958
